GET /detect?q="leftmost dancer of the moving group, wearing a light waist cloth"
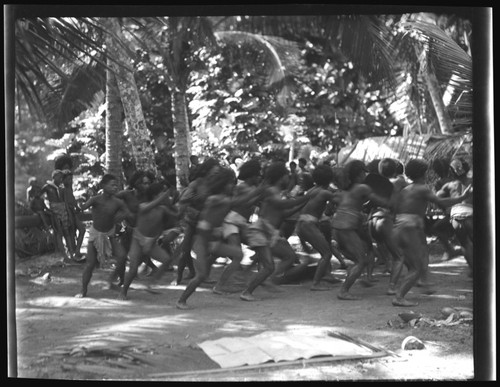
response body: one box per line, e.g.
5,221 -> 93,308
75,174 -> 133,298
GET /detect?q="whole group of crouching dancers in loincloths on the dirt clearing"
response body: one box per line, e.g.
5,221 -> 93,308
69,158 -> 473,309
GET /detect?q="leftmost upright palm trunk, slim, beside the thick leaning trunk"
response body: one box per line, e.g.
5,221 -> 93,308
106,65 -> 123,187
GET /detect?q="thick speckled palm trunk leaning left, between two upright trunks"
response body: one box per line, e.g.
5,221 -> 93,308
105,18 -> 157,173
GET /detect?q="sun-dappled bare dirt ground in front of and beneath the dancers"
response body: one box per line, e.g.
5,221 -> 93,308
10,236 -> 474,381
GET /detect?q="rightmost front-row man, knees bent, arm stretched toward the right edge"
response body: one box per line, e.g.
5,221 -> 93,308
392,159 -> 472,306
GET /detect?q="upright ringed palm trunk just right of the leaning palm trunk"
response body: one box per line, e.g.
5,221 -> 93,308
172,89 -> 191,189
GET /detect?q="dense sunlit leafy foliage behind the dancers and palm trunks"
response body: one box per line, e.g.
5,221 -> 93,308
11,12 -> 471,200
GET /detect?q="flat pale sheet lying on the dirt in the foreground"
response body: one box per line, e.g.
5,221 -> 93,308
198,332 -> 374,368
